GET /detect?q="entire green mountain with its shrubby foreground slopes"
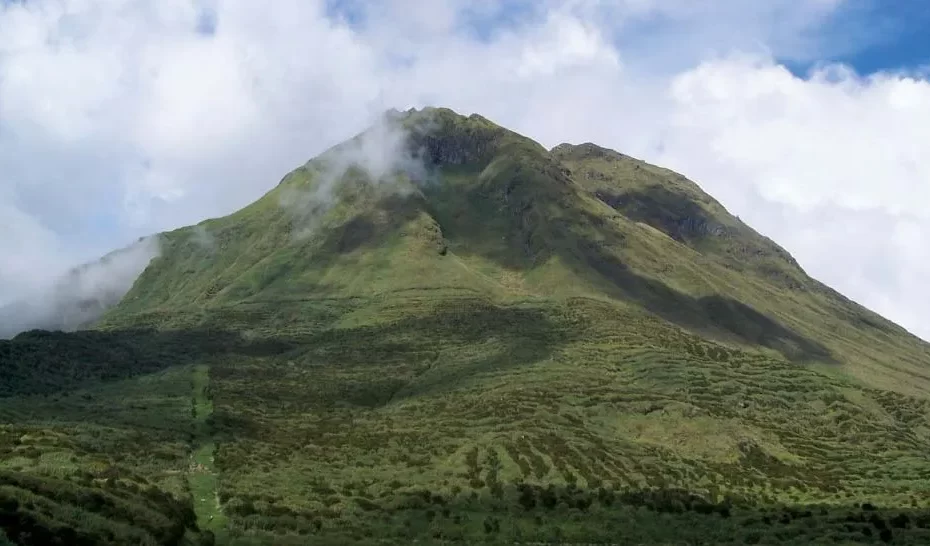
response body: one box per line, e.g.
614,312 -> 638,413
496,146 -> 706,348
0,108 -> 930,544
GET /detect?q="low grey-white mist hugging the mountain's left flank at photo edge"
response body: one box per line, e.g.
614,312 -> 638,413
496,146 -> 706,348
0,236 -> 160,339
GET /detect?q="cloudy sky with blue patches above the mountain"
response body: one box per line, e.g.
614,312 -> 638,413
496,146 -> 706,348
0,0 -> 930,339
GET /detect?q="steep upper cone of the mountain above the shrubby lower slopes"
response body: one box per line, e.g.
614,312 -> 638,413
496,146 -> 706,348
103,105 -> 930,394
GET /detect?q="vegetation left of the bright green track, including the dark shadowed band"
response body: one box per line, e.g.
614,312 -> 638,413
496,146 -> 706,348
0,332 -> 223,545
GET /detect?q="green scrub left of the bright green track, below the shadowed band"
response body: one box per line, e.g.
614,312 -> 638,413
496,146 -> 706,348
0,348 -> 201,545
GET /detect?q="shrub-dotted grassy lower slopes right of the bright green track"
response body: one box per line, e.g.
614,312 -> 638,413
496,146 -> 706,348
176,299 -> 930,544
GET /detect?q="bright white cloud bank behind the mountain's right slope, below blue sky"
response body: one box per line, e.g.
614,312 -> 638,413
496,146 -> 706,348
640,58 -> 930,337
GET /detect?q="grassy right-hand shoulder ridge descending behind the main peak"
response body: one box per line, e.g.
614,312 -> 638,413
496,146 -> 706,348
553,139 -> 930,396
